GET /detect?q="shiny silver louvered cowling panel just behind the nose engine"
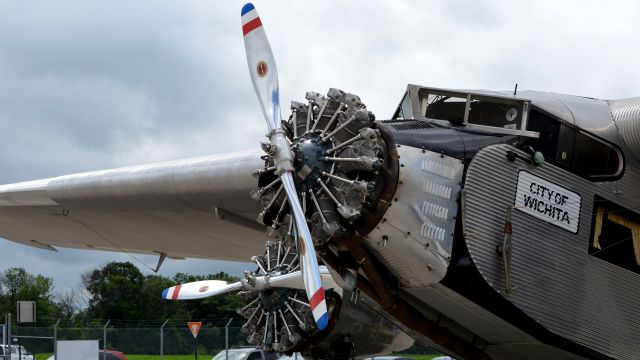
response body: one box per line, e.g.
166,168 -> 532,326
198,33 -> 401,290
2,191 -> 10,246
367,146 -> 463,288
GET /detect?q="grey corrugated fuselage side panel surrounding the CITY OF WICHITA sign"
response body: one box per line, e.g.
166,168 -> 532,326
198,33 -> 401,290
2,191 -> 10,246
463,145 -> 640,359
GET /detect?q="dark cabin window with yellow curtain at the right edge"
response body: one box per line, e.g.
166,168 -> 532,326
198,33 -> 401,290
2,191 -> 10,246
589,196 -> 640,273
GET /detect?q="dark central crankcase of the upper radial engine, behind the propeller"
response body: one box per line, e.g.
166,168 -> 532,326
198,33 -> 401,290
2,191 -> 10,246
291,131 -> 331,191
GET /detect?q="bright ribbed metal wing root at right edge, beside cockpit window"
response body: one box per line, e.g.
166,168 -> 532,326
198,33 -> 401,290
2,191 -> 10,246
609,98 -> 640,160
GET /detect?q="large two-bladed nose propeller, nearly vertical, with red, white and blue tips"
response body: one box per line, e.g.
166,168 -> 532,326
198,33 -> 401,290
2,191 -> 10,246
241,3 -> 329,330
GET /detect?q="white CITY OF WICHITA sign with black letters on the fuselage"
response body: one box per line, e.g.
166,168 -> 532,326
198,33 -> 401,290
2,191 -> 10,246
513,170 -> 582,234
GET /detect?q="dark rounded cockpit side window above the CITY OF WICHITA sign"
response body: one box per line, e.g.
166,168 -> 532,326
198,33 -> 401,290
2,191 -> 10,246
528,110 -> 624,181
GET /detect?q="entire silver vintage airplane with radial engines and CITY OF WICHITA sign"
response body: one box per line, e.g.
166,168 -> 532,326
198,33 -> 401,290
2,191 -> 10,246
0,4 -> 640,359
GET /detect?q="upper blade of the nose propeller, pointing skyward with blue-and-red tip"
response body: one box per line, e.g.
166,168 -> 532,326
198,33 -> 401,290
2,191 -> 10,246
241,3 -> 280,131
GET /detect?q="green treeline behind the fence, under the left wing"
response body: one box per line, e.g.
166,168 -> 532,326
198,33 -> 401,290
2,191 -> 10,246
0,262 -> 244,327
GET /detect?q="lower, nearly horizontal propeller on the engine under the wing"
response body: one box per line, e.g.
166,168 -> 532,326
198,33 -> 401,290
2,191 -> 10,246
162,266 -> 337,300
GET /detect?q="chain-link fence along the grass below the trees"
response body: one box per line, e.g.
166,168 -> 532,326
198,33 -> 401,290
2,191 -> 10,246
5,321 -> 438,360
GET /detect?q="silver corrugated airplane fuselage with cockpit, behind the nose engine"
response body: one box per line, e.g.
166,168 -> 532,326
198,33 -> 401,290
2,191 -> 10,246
365,85 -> 640,359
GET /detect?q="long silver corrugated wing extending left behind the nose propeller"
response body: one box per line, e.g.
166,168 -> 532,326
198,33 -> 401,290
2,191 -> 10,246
0,151 -> 264,261
